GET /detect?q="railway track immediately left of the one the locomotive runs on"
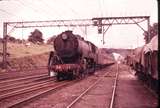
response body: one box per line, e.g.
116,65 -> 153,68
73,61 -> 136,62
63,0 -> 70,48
0,77 -> 53,100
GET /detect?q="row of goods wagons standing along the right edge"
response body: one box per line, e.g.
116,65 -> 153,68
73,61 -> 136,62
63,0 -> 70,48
128,36 -> 158,92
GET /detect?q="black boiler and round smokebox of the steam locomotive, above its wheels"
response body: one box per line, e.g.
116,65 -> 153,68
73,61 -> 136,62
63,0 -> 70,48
54,31 -> 97,63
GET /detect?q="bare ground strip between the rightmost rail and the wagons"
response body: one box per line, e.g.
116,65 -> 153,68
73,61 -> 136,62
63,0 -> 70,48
114,64 -> 158,108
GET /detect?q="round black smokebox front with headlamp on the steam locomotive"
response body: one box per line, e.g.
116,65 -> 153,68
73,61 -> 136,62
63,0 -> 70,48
54,31 -> 78,62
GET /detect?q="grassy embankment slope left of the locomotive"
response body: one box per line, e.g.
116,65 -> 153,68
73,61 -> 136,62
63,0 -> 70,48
0,43 -> 53,70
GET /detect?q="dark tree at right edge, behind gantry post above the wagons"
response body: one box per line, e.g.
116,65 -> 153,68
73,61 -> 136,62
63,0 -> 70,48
143,23 -> 158,43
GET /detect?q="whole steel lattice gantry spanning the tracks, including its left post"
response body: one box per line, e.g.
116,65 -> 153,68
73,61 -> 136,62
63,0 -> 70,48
3,16 -> 150,68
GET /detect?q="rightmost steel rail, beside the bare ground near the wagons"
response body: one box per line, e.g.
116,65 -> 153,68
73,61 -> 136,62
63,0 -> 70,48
109,63 -> 119,108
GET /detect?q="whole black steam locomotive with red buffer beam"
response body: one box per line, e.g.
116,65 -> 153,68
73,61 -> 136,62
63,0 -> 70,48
48,31 -> 98,80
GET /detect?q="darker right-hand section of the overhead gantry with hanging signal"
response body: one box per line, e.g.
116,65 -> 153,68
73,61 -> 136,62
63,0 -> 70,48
92,16 -> 150,44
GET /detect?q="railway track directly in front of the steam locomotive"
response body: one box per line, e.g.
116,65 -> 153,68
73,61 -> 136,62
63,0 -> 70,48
0,80 -> 78,108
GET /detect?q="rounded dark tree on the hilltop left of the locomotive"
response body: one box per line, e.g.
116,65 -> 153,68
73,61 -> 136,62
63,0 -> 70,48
28,29 -> 44,43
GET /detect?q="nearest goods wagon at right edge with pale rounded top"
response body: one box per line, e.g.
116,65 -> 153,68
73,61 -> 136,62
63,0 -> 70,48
141,36 -> 158,92
